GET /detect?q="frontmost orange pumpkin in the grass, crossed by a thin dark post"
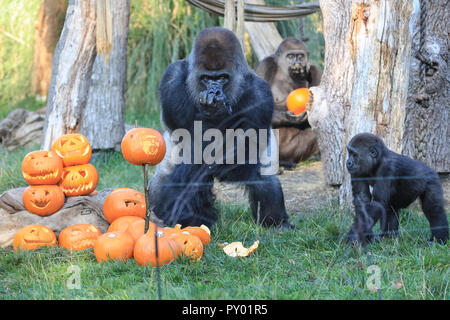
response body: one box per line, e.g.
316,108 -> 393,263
134,231 -> 181,267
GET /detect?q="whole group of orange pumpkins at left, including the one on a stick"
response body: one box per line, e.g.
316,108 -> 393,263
13,128 -> 210,266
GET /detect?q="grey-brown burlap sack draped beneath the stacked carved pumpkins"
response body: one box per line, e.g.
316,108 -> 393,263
0,188 -> 112,248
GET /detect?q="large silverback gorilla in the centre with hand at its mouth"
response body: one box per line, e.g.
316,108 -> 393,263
149,27 -> 292,228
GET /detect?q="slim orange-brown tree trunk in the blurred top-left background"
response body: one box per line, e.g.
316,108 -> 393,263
31,0 -> 67,97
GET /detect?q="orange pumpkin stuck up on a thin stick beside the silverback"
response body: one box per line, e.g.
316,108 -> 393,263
121,128 -> 166,166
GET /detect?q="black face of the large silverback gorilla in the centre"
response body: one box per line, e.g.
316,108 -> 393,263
197,70 -> 232,114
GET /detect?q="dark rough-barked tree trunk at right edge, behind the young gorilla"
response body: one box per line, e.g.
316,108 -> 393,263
403,0 -> 450,172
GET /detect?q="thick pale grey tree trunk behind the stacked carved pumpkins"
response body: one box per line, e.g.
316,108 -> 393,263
42,0 -> 129,149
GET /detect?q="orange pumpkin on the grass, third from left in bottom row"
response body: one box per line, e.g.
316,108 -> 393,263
94,231 -> 134,262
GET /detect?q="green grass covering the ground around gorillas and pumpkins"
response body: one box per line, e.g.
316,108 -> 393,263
0,148 -> 450,299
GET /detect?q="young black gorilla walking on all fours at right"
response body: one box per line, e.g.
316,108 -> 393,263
346,133 -> 448,244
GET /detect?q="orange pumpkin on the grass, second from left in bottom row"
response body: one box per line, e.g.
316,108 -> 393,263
58,224 -> 102,251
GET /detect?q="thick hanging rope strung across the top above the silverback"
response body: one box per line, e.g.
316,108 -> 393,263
186,0 -> 320,22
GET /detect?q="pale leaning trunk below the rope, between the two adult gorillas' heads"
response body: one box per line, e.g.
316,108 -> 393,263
244,0 -> 283,61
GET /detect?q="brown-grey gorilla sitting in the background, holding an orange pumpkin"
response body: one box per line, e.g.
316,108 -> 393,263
256,37 -> 322,168
